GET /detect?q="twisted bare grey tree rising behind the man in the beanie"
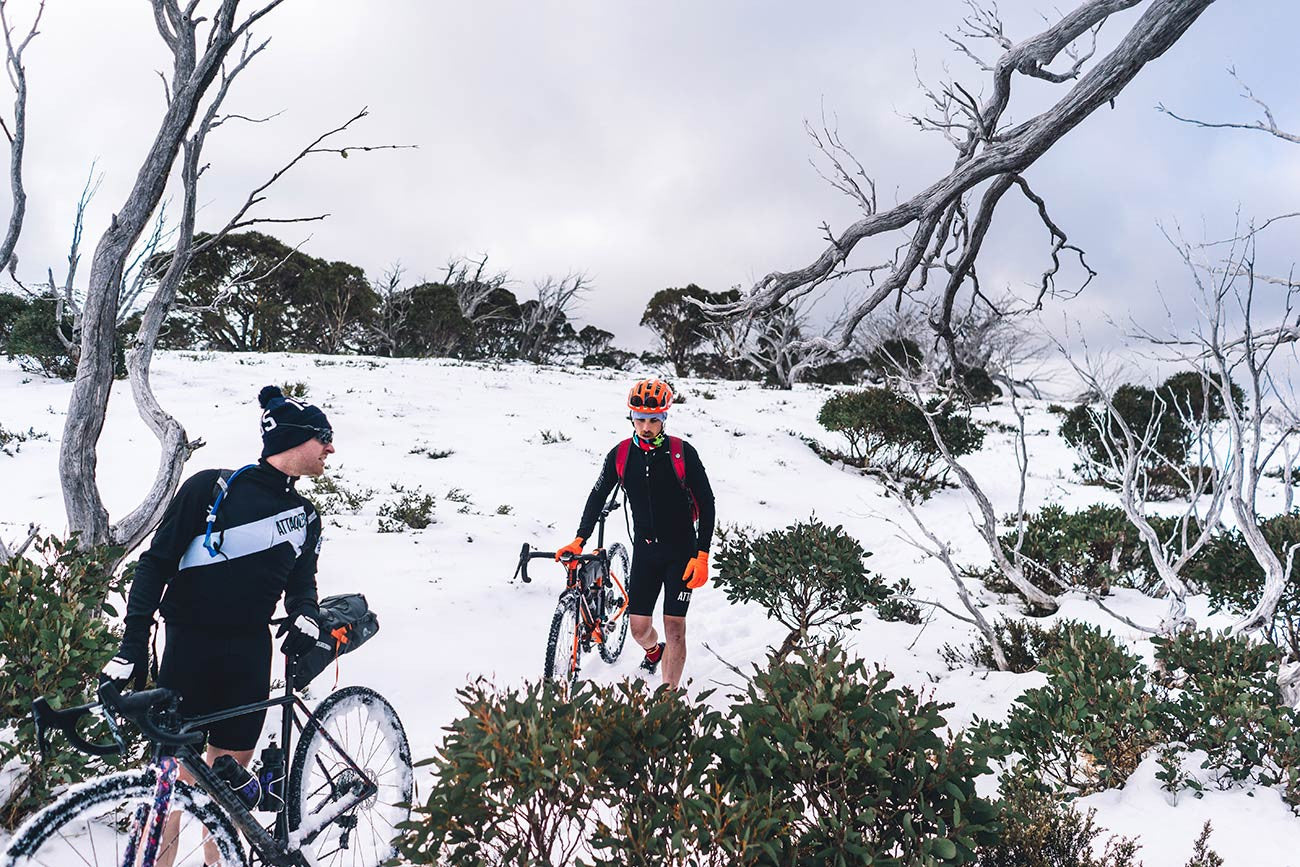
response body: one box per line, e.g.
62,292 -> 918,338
60,0 -> 405,551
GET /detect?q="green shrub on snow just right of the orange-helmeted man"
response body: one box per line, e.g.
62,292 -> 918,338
714,517 -> 892,658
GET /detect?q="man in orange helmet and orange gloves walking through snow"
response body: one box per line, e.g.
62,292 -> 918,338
555,380 -> 714,686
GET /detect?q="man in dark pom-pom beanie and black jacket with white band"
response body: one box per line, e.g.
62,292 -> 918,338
104,386 -> 334,776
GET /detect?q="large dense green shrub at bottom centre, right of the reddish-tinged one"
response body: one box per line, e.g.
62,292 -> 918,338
715,645 -> 1005,866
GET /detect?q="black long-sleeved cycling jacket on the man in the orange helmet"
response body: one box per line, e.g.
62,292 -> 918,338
577,437 -> 714,551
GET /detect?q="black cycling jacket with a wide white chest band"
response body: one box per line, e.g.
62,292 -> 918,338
122,461 -> 321,647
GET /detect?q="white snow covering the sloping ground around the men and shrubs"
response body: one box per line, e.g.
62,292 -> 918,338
0,354 -> 1300,867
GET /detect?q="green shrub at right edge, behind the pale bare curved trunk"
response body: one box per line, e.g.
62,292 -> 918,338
1183,511 -> 1300,658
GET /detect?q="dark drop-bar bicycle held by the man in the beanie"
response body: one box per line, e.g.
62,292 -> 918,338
0,649 -> 413,867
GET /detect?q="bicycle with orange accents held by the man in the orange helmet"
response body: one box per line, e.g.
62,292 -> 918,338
515,494 -> 629,685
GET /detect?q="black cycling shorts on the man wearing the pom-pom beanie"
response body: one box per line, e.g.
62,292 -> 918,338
159,624 -> 270,750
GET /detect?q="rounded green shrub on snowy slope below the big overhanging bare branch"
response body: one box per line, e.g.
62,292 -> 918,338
818,389 -> 984,493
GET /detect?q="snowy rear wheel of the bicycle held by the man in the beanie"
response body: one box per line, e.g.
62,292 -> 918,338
287,686 -> 415,867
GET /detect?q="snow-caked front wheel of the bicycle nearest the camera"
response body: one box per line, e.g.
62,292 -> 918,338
0,768 -> 248,867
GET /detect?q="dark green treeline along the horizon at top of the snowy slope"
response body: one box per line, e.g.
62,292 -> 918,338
0,231 -> 883,382
